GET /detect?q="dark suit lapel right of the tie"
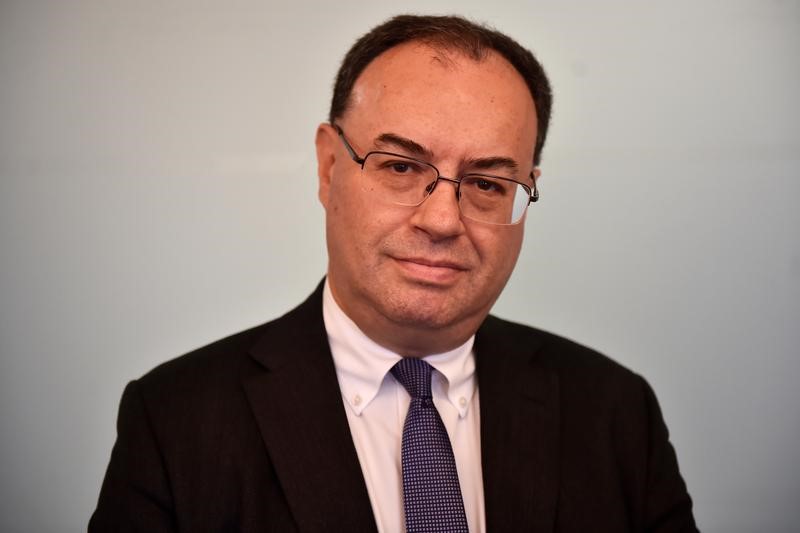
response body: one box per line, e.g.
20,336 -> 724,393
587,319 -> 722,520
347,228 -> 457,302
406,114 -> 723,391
475,317 -> 559,533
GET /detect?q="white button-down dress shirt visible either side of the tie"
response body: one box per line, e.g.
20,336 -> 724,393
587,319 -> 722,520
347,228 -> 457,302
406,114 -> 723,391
322,280 -> 486,533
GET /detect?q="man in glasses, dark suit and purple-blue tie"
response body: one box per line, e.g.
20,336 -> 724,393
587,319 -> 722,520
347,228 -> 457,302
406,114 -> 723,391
89,16 -> 696,532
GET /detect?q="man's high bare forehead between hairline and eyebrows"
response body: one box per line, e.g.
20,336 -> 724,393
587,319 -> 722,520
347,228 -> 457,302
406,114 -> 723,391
343,42 -> 536,159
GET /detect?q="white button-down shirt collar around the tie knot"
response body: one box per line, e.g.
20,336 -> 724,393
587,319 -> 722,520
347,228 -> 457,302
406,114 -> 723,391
322,278 -> 476,418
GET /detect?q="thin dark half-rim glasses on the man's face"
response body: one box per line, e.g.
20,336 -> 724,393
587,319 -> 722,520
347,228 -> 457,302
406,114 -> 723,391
333,124 -> 539,225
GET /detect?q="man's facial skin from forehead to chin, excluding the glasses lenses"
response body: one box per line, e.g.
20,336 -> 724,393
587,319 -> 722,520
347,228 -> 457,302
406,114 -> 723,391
317,43 -> 536,356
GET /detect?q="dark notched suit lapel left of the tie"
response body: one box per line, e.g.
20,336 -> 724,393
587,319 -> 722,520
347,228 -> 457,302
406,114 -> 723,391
244,284 -> 376,532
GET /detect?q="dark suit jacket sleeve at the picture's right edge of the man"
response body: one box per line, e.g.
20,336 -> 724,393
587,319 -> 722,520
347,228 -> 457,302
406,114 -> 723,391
642,379 -> 697,533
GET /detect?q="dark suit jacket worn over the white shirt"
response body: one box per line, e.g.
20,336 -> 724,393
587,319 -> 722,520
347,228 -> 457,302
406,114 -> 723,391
89,280 -> 695,533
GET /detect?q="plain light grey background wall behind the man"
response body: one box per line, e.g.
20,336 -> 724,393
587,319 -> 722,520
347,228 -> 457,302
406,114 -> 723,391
0,0 -> 800,532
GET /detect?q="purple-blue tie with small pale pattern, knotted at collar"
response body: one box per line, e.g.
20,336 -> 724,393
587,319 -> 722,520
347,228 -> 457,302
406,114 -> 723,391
392,358 -> 469,533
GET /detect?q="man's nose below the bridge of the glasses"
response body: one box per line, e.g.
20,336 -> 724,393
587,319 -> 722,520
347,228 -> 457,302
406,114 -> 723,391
411,177 -> 464,241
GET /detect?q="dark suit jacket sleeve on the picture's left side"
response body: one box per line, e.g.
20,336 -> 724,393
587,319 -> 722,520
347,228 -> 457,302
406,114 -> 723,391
88,381 -> 177,533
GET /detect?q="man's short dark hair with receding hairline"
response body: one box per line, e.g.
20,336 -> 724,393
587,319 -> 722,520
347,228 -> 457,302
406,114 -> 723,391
328,15 -> 553,165
